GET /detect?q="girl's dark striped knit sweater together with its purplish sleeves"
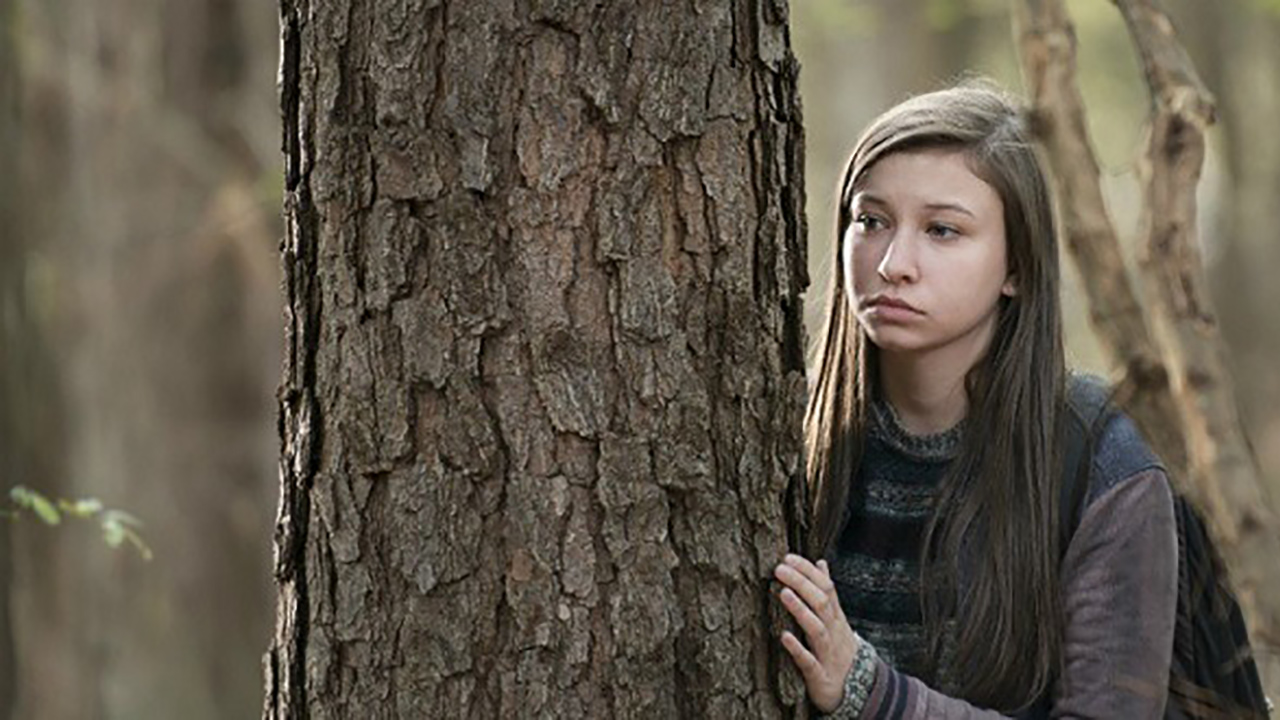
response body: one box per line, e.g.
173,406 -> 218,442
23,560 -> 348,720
828,406 -> 1178,720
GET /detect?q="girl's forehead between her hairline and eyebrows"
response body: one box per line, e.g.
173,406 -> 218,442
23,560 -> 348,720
854,149 -> 1004,213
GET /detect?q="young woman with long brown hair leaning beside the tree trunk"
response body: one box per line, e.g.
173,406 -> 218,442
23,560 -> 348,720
776,87 -> 1178,719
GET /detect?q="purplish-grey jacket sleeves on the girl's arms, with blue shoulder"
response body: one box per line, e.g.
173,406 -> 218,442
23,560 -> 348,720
836,407 -> 1178,720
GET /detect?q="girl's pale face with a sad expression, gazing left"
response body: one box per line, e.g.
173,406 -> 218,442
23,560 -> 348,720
841,149 -> 1015,370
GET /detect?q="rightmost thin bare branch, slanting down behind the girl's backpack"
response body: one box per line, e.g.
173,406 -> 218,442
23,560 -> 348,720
1115,0 -> 1280,646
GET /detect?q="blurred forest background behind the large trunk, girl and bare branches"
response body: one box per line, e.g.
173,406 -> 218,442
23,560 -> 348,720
0,0 -> 1280,720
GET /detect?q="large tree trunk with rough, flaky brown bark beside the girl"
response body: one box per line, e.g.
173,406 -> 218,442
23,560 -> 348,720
265,0 -> 806,717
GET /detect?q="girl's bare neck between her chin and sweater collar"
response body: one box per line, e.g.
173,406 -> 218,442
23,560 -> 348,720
879,352 -> 972,436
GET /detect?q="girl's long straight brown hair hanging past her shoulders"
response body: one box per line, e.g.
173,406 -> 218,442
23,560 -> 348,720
805,85 -> 1065,711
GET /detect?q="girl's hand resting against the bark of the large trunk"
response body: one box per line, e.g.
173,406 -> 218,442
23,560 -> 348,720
773,555 -> 859,714
